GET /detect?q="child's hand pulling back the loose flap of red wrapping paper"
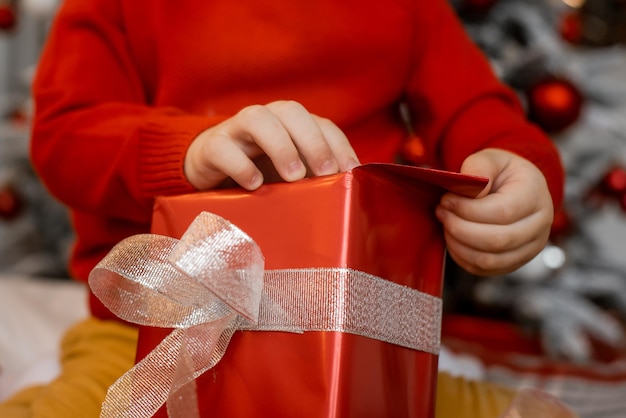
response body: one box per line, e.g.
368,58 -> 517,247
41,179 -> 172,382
437,149 -> 554,276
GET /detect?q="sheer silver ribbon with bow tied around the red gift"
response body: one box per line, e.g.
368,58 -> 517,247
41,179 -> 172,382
89,212 -> 442,418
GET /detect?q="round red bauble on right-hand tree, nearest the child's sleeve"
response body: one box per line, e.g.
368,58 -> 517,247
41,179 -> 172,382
526,76 -> 583,133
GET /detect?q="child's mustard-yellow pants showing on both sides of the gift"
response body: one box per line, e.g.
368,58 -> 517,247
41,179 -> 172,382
0,318 -> 514,418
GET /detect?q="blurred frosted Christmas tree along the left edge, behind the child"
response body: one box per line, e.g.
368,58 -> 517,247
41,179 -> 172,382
0,0 -> 71,277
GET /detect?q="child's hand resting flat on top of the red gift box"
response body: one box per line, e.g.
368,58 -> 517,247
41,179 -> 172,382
184,101 -> 359,190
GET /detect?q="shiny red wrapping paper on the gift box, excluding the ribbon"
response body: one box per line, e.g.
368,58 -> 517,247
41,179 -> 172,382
137,164 -> 486,418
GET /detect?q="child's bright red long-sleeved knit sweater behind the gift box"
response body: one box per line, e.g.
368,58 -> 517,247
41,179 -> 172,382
32,0 -> 563,317
